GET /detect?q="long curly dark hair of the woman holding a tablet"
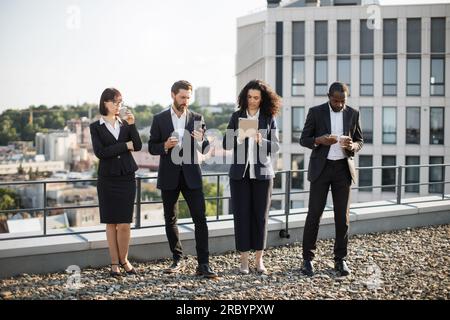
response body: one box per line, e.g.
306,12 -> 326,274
238,80 -> 281,116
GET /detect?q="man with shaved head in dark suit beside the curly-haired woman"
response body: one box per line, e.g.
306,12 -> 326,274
300,82 -> 363,276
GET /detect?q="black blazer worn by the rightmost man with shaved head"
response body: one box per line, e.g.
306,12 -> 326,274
300,102 -> 364,183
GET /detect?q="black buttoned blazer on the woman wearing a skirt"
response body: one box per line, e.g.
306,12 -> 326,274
89,120 -> 142,177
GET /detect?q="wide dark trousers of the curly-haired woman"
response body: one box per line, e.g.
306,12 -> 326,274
230,170 -> 273,252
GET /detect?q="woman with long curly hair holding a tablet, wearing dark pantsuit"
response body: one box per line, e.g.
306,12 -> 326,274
223,80 -> 281,274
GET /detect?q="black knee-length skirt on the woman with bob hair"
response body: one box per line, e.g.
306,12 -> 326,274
97,173 -> 136,224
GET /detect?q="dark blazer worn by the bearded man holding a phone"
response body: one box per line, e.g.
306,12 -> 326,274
148,108 -> 209,190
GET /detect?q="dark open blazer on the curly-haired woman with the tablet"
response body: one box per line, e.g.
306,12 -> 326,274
223,110 -> 280,180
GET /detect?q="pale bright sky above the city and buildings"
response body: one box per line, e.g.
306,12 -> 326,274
0,0 -> 450,112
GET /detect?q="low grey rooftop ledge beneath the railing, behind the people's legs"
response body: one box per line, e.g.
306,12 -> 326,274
0,195 -> 450,278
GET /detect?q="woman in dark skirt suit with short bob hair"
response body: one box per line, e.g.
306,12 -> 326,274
90,88 -> 142,276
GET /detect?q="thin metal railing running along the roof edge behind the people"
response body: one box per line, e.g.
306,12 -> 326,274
0,164 -> 450,241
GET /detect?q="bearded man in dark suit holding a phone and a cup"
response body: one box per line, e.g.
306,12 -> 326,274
148,80 -> 217,278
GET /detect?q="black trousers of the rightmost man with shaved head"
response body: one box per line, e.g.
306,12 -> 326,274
303,159 -> 351,261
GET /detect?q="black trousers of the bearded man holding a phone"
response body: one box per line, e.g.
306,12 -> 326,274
161,172 -> 209,264
